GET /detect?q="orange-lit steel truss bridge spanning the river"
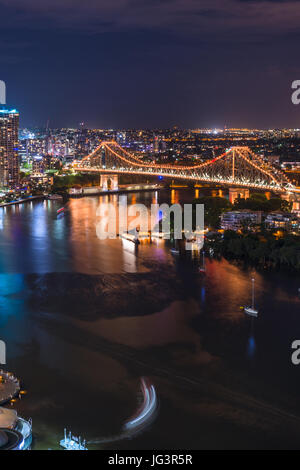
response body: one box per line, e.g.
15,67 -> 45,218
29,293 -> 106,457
74,141 -> 300,194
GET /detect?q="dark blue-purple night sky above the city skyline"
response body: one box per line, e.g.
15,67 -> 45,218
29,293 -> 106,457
0,0 -> 300,128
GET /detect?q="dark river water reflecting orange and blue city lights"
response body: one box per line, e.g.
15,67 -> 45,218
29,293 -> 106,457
0,190 -> 300,449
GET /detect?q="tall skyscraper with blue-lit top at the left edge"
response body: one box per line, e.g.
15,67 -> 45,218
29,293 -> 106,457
0,104 -> 19,187
